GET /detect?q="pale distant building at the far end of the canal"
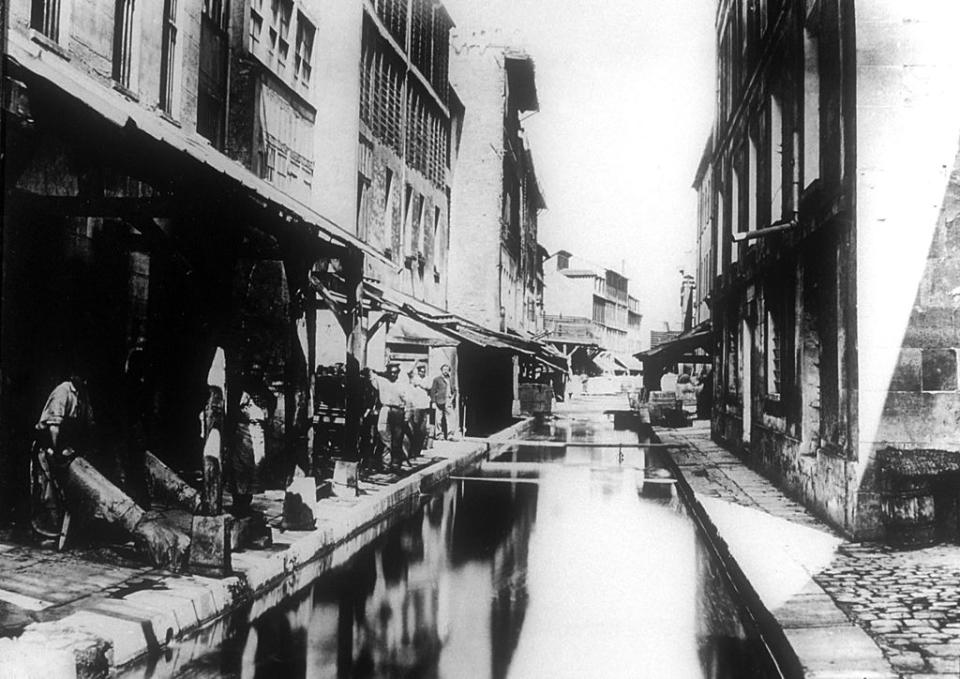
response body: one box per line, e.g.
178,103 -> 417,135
543,250 -> 643,357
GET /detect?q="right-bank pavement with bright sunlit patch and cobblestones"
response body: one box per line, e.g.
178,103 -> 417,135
656,421 -> 960,679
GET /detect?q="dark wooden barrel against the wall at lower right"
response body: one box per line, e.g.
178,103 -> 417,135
880,477 -> 937,549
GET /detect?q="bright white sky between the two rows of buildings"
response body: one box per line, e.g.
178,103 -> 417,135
444,0 -> 715,341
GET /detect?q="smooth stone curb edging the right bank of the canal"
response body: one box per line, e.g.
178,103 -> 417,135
654,427 -> 899,679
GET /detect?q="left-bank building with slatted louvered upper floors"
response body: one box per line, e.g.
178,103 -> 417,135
356,0 -> 463,370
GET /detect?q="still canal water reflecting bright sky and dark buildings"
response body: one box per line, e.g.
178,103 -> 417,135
126,404 -> 779,679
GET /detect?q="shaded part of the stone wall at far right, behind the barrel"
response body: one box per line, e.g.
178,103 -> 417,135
874,141 -> 960,547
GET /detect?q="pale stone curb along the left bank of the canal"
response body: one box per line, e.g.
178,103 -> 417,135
0,419 -> 533,679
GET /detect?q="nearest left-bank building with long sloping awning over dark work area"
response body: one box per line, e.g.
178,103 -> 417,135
0,0 -> 384,500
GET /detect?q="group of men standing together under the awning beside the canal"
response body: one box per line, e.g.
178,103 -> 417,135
359,362 -> 456,469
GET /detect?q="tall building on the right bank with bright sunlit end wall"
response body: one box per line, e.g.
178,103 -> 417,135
696,0 -> 960,542
